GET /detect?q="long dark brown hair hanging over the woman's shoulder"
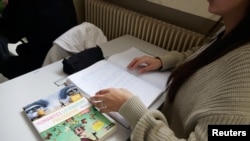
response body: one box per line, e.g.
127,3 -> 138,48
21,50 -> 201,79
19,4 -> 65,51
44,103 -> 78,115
166,8 -> 250,102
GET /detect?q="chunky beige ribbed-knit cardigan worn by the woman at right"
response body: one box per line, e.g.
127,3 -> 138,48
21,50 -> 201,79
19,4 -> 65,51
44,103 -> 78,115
119,40 -> 250,141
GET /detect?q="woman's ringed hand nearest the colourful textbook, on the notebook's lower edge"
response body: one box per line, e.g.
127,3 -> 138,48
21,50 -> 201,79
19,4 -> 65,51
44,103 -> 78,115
90,88 -> 133,113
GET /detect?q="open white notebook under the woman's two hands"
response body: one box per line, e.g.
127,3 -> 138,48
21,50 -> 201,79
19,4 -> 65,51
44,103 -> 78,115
68,47 -> 170,127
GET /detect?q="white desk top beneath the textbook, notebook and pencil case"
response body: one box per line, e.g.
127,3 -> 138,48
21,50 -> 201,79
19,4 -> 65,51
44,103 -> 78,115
0,35 -> 166,141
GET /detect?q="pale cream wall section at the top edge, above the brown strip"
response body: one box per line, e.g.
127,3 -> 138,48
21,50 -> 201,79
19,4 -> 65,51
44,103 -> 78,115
148,0 -> 218,20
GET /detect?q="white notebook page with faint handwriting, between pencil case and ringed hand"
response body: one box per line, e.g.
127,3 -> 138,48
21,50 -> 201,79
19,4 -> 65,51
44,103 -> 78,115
68,60 -> 162,107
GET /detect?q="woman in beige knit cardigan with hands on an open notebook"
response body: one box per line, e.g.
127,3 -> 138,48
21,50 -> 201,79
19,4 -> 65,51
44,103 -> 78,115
91,0 -> 250,141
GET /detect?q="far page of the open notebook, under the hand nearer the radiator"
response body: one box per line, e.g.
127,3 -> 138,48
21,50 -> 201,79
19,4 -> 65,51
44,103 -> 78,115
107,47 -> 170,90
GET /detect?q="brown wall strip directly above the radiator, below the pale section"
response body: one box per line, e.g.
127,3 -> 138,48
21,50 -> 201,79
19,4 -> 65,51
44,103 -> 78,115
104,0 -> 218,34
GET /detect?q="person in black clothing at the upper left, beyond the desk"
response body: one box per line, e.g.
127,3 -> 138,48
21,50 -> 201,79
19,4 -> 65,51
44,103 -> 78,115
0,0 -> 78,79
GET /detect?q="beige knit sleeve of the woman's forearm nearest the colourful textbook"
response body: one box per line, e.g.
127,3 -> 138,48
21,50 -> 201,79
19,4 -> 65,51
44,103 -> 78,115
119,96 -> 186,141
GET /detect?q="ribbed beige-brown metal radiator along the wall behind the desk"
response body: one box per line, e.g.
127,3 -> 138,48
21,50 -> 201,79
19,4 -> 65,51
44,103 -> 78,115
84,0 -> 203,51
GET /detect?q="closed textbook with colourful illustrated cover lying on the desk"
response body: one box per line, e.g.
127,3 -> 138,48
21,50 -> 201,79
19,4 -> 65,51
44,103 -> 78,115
23,84 -> 117,141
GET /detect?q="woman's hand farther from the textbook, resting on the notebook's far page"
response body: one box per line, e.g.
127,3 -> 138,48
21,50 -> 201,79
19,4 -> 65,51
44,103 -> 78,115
127,55 -> 162,73
